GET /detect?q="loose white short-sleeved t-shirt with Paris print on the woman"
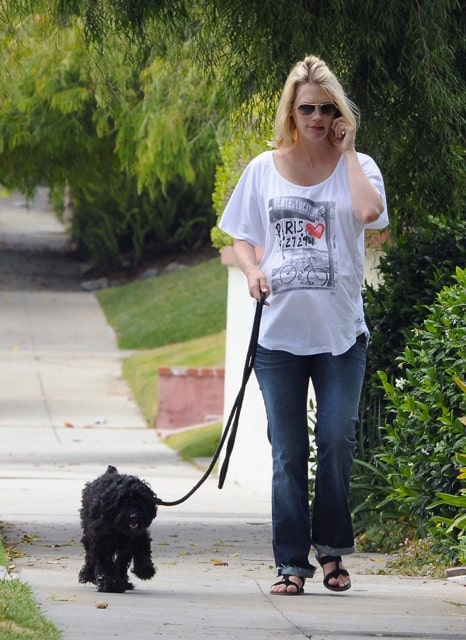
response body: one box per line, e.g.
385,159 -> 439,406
219,151 -> 388,355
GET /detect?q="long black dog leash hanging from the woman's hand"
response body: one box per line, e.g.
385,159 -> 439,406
156,293 -> 265,507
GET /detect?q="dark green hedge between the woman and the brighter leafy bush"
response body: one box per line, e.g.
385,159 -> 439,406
358,215 -> 466,461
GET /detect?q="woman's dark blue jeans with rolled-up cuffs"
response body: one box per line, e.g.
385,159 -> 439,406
254,336 -> 366,577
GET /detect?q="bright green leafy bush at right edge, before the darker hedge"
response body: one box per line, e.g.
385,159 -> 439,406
373,268 -> 466,556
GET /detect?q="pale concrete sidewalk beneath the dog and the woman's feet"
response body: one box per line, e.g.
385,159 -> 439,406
0,196 -> 466,640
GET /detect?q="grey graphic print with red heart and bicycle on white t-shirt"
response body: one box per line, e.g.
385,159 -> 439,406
269,196 -> 337,294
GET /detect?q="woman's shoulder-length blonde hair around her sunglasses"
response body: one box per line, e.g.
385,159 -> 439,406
271,55 -> 359,148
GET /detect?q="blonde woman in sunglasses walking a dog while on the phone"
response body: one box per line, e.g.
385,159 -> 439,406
219,56 -> 388,595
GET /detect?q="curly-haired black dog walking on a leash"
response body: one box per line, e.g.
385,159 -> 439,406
79,466 -> 157,593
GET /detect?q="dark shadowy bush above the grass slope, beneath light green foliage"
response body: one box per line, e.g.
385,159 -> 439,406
73,174 -> 215,266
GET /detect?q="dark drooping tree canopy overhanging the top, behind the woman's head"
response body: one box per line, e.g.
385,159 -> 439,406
3,0 -> 466,232
